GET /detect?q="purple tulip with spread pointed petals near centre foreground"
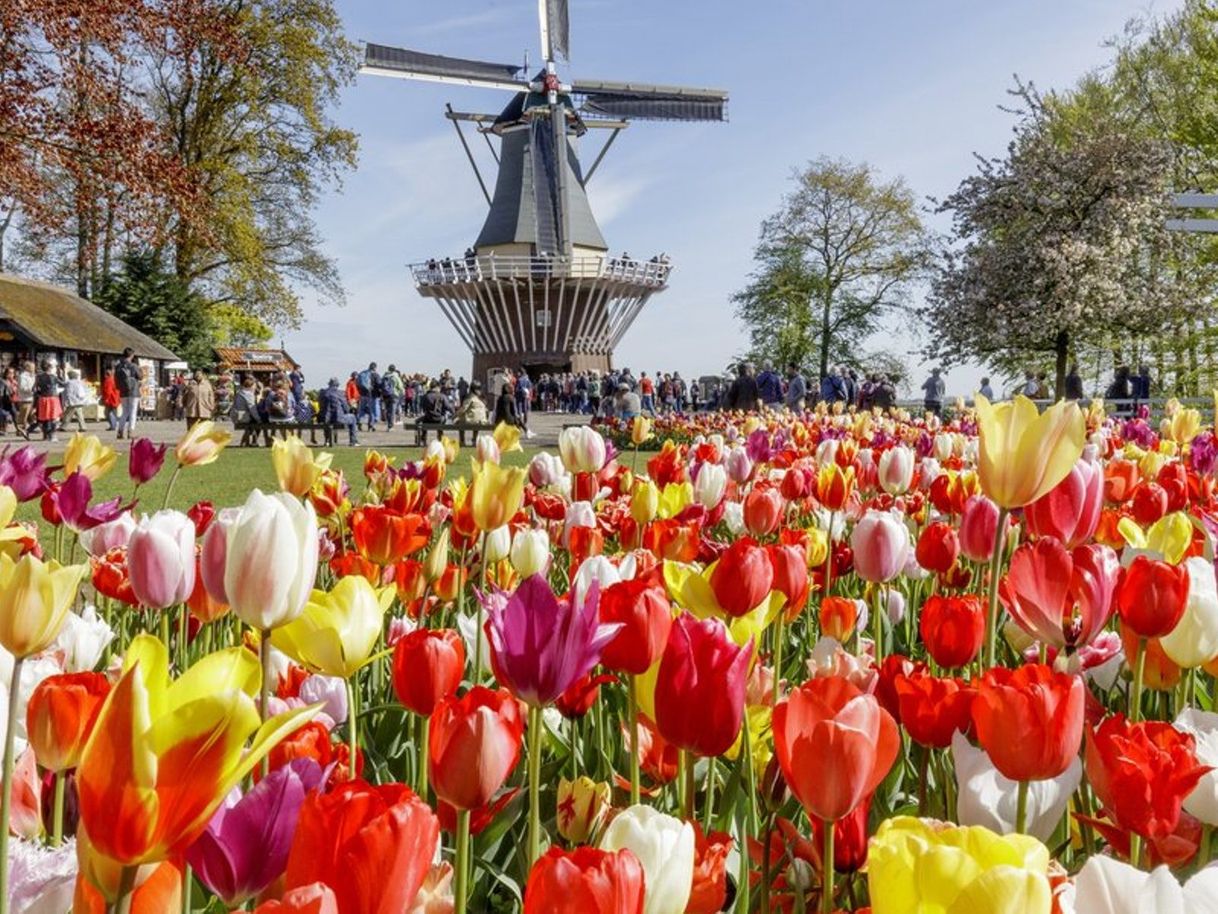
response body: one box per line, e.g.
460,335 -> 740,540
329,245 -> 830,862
482,574 -> 621,708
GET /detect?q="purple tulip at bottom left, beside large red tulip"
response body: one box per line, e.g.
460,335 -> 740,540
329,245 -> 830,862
186,758 -> 325,908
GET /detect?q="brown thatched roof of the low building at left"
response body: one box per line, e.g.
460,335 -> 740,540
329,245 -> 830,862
0,273 -> 178,362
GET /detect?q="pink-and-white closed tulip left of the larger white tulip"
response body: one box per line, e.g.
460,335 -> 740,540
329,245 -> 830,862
127,511 -> 195,609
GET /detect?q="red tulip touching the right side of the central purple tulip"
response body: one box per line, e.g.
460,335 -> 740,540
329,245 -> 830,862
598,567 -> 672,675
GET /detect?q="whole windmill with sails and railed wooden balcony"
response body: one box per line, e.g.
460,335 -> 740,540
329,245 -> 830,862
361,0 -> 727,378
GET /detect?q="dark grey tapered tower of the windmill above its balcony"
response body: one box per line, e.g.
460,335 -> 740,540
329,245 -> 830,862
474,93 -> 609,253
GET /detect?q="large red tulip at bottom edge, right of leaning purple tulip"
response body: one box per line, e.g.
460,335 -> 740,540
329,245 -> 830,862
284,781 -> 440,914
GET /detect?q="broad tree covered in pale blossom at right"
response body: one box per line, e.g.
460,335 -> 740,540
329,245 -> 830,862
921,83 -> 1192,396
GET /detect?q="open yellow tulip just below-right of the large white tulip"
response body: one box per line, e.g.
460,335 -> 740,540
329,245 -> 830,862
270,574 -> 393,679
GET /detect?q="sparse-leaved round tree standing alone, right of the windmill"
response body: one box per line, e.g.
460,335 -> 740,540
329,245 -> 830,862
733,157 -> 927,377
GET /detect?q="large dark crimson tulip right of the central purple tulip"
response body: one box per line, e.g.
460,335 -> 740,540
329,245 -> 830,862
655,613 -> 753,757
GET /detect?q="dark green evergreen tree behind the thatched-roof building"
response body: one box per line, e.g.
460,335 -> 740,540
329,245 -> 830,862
96,250 -> 214,367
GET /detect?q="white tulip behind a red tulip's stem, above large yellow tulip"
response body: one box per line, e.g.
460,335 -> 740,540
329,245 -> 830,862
951,732 -> 1083,841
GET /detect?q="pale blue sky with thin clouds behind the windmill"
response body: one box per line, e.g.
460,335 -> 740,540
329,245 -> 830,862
283,0 -> 1180,394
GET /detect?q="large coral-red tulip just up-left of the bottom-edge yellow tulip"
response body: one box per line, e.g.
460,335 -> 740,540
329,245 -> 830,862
773,676 -> 901,821
